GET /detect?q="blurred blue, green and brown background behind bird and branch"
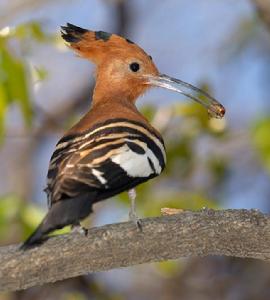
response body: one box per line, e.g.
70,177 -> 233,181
0,0 -> 270,300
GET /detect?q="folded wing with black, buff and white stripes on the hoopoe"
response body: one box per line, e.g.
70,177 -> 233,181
45,119 -> 166,206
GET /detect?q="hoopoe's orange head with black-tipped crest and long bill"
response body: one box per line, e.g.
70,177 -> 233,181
61,23 -> 225,118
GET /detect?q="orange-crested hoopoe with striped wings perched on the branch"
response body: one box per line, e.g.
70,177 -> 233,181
22,23 -> 225,249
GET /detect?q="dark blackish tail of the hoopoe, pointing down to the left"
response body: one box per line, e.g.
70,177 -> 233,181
20,194 -> 94,250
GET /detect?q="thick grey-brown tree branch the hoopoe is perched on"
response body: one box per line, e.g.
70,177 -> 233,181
0,209 -> 270,291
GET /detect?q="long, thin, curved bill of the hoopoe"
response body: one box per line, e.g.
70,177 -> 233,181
147,74 -> 226,119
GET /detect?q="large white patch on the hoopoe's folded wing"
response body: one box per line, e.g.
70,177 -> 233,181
111,144 -> 161,177
